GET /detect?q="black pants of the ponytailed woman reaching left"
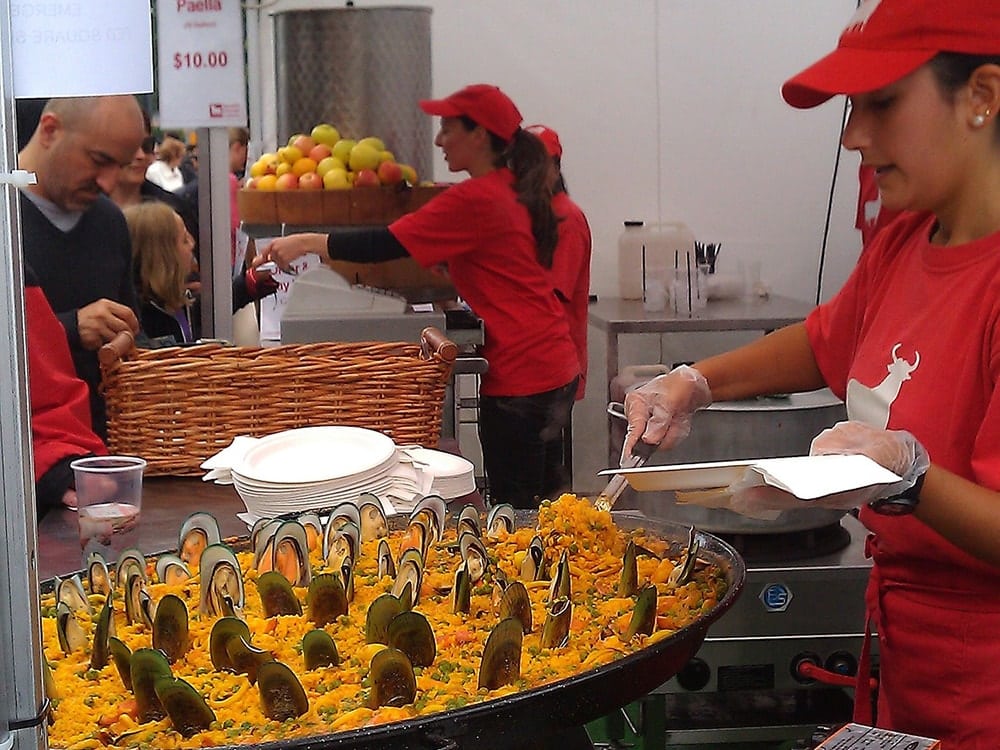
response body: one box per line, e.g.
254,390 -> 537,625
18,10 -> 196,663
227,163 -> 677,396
479,378 -> 579,508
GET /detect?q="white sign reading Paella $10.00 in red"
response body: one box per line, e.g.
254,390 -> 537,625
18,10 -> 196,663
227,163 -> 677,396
156,0 -> 247,128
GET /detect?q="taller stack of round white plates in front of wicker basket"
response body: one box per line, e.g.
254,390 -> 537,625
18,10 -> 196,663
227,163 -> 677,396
231,426 -> 399,516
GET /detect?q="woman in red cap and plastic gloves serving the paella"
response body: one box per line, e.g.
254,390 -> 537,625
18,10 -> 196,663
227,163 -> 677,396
625,0 -> 1000,750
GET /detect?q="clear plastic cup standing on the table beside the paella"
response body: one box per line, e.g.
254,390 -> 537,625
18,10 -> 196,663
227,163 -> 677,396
70,456 -> 146,563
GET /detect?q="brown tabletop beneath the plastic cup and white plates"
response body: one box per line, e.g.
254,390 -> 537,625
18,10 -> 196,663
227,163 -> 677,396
38,477 -> 482,581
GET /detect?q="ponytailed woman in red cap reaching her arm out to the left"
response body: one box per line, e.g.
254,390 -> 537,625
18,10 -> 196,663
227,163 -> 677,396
267,84 -> 580,507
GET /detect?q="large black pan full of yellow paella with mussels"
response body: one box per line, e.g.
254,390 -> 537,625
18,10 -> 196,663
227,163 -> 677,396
42,496 -> 745,750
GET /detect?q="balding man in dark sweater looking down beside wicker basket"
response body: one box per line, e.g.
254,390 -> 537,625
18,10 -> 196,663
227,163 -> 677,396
18,96 -> 145,438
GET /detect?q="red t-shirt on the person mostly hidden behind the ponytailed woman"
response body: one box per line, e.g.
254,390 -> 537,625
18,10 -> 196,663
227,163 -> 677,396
549,193 -> 592,401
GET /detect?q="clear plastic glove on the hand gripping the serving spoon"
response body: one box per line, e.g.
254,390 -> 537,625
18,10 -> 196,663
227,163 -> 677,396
621,365 -> 712,464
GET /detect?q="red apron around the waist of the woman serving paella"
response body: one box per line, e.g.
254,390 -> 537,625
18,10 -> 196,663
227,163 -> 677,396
854,535 -> 1000,750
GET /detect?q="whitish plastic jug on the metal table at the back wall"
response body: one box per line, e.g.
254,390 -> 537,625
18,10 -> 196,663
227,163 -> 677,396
618,221 -> 694,299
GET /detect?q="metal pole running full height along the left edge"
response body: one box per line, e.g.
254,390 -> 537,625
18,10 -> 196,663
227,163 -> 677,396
0,0 -> 47,750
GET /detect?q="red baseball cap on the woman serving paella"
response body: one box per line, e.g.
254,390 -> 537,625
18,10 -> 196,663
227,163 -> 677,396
781,0 -> 1000,109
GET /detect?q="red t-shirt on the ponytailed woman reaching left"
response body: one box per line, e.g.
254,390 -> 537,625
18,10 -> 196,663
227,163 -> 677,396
389,169 -> 580,396
